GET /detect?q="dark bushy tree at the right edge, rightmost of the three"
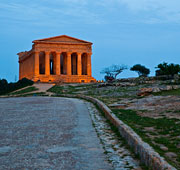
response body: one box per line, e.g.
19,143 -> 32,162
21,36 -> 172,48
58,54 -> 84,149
155,62 -> 180,76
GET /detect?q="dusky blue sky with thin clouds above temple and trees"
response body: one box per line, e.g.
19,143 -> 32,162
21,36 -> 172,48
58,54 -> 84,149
0,0 -> 180,81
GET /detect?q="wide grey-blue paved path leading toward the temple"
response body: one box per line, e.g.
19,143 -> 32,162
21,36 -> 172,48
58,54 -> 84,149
0,97 -> 112,170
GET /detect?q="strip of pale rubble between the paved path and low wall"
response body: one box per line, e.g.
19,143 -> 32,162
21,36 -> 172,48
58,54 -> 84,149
86,102 -> 141,170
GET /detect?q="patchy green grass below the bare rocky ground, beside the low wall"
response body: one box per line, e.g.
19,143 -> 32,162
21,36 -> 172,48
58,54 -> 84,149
112,109 -> 180,169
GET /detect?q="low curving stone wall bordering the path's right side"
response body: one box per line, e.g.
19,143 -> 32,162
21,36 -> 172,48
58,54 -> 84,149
58,95 -> 176,170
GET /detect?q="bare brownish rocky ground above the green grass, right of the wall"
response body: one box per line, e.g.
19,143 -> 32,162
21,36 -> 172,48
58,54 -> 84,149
109,96 -> 180,119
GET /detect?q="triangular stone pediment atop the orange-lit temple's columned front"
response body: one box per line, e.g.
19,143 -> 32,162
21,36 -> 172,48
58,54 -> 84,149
33,35 -> 92,44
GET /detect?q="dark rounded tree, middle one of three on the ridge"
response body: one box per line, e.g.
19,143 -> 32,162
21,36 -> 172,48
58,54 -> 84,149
130,64 -> 150,77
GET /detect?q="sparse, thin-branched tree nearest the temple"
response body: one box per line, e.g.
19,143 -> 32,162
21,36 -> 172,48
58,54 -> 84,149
101,65 -> 127,81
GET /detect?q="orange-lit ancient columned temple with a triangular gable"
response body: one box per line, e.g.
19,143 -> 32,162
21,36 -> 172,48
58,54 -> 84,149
18,35 -> 96,83
